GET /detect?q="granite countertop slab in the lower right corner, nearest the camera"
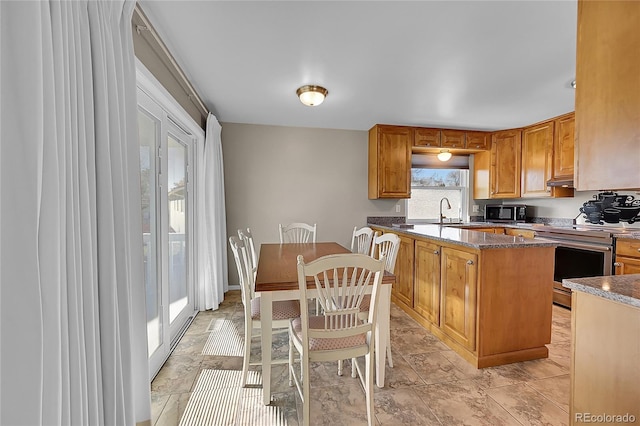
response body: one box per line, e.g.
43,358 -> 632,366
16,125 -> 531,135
562,274 -> 640,308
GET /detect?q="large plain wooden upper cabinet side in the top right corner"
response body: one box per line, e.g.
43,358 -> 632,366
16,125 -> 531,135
575,0 -> 640,191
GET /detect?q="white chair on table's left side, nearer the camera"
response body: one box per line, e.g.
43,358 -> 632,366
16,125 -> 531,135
229,237 -> 300,387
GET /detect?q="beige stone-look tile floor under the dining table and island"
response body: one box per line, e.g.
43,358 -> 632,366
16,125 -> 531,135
151,291 -> 571,426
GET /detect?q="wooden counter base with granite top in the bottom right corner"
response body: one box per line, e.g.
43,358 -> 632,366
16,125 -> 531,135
562,274 -> 640,424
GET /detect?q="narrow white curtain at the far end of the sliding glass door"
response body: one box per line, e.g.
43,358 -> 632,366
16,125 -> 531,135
197,113 -> 229,311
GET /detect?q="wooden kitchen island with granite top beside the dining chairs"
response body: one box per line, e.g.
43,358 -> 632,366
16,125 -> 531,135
370,224 -> 557,368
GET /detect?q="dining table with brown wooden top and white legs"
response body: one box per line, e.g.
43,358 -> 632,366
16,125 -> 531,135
255,242 -> 395,405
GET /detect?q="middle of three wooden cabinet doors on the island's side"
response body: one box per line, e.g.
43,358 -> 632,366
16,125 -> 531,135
413,241 -> 440,325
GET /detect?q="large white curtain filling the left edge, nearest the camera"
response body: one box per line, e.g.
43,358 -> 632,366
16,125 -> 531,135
0,0 -> 151,425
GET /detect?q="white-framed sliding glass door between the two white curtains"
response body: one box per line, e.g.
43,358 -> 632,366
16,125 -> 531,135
138,89 -> 194,377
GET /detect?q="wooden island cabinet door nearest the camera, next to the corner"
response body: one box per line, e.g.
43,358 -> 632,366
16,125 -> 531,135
440,248 -> 478,351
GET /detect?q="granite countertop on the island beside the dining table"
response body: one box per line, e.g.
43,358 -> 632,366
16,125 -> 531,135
369,224 -> 558,250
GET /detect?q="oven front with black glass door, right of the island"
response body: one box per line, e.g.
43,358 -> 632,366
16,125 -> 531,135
553,241 -> 613,308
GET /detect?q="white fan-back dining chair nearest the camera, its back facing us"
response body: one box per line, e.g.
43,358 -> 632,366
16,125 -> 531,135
289,253 -> 385,425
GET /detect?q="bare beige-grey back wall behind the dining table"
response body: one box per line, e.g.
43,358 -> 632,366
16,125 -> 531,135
222,123 -> 404,285
